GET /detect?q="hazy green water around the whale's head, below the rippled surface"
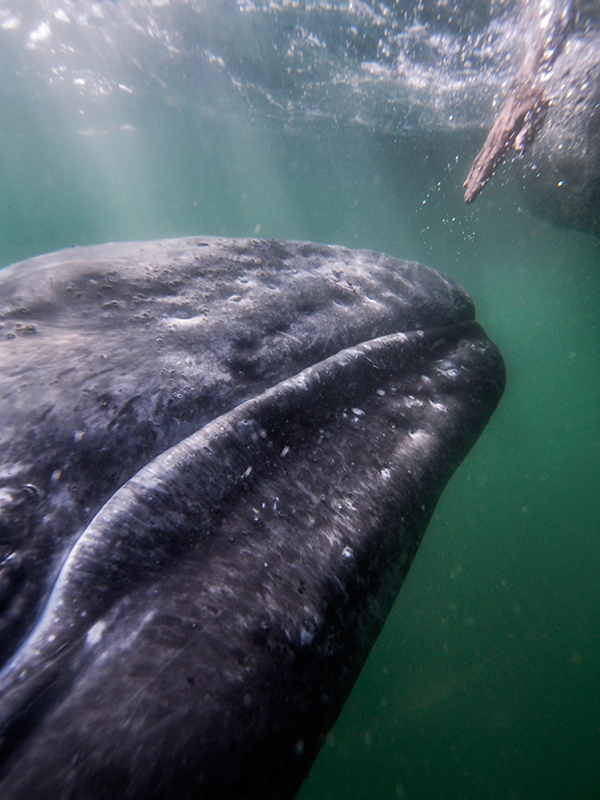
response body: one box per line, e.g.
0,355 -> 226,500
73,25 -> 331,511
0,57 -> 600,800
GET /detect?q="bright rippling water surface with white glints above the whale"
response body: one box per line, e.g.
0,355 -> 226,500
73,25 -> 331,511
0,0 -> 525,132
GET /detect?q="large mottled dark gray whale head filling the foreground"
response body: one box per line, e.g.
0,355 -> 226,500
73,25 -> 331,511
0,238 -> 504,800
